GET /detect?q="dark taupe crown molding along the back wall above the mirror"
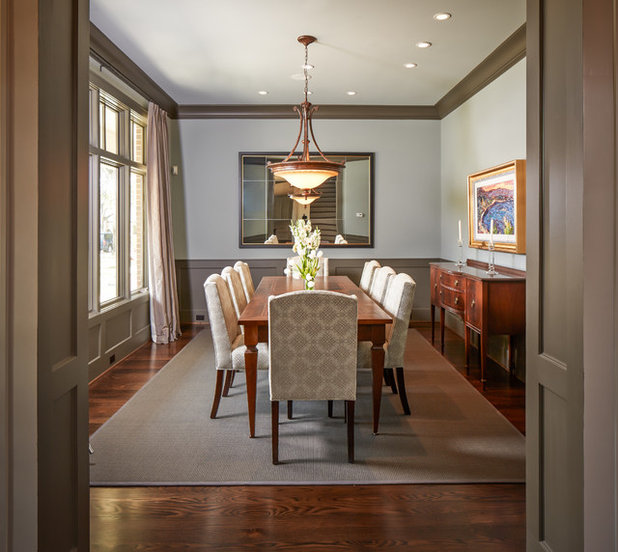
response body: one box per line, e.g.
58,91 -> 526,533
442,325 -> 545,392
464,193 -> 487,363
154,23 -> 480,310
177,104 -> 439,119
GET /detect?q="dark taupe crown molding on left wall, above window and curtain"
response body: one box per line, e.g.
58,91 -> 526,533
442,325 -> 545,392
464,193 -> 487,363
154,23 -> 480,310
90,23 -> 178,117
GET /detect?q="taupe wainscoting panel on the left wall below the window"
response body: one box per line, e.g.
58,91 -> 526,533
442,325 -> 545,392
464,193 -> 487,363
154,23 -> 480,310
88,293 -> 150,381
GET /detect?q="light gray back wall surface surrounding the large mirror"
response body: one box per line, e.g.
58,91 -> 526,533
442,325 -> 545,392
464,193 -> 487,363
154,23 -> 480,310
170,119 -> 440,259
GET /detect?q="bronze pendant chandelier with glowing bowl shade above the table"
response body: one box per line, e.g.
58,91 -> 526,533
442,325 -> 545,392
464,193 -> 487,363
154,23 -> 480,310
268,35 -> 345,190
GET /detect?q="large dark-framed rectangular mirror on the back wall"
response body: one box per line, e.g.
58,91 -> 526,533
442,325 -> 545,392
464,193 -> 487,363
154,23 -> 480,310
239,152 -> 374,248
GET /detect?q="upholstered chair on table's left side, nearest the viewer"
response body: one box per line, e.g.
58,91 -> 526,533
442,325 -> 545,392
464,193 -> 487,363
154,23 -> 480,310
204,274 -> 268,418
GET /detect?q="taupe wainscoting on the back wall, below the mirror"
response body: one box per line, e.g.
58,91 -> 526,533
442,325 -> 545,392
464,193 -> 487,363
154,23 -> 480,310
176,258 -> 441,322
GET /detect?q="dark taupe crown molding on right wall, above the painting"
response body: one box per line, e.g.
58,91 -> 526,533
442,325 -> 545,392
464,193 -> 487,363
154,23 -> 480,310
435,23 -> 526,119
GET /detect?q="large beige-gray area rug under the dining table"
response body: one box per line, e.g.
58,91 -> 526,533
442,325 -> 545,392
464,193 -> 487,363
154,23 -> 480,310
90,330 -> 525,486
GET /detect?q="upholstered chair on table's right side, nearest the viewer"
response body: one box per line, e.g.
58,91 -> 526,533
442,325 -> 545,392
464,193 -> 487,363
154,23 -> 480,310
358,274 -> 416,416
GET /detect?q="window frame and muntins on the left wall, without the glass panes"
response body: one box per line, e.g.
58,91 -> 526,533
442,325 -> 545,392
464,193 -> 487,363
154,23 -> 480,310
88,79 -> 148,317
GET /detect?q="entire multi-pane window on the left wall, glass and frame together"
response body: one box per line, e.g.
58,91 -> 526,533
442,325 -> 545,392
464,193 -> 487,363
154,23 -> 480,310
89,84 -> 147,313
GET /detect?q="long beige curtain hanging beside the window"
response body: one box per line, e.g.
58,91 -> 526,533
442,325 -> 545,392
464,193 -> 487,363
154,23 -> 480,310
146,102 -> 181,343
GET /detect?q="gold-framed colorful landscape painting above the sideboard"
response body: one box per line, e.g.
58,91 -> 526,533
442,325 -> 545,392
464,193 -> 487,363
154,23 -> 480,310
468,159 -> 526,253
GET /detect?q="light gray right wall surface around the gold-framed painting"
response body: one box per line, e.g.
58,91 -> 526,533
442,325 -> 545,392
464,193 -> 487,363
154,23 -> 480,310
440,59 -> 526,270
